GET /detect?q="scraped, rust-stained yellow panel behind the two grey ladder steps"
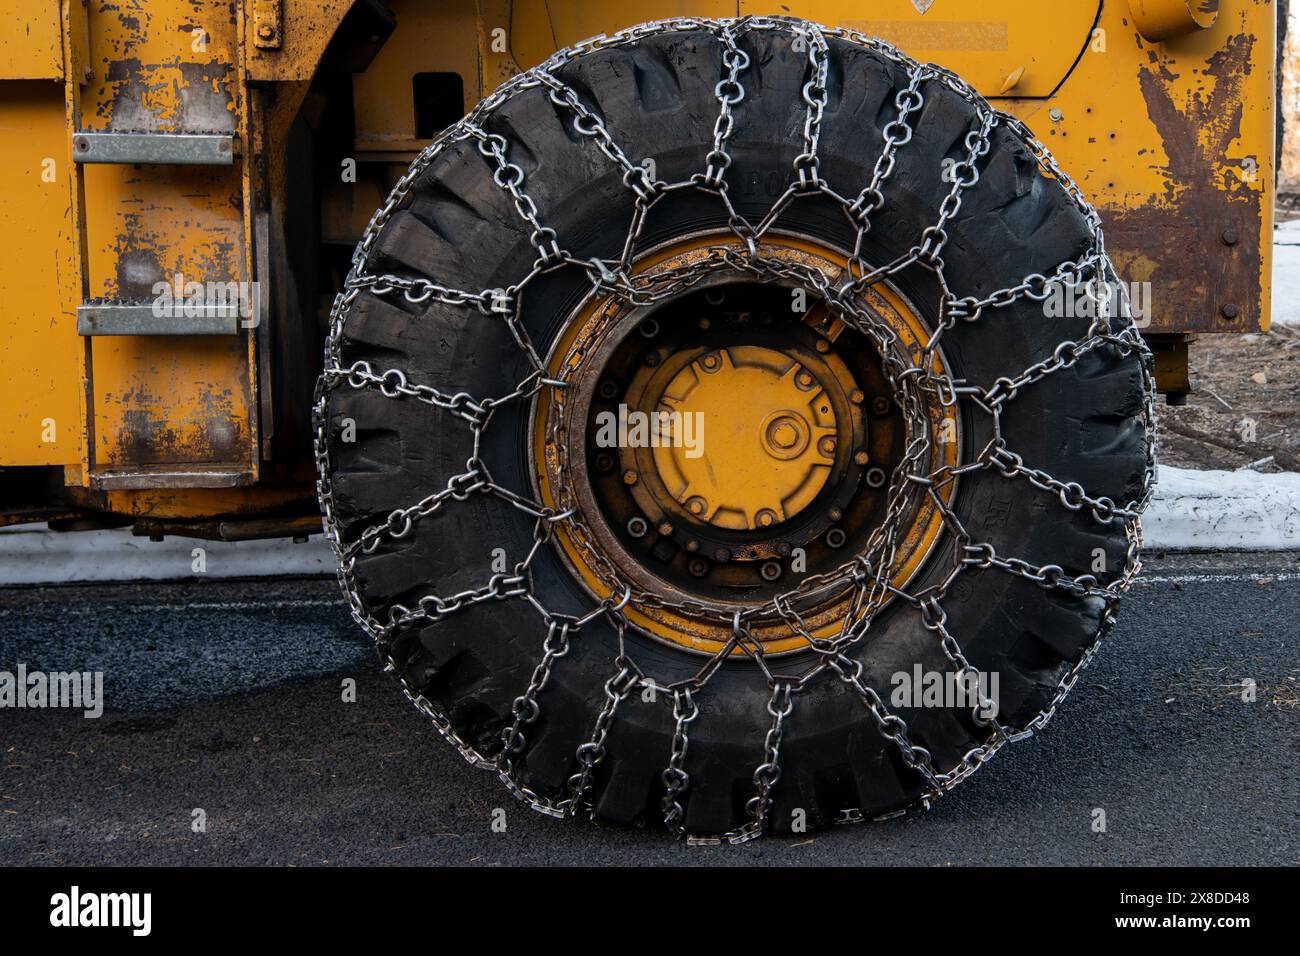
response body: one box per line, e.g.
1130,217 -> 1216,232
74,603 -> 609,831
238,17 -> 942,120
81,0 -> 256,481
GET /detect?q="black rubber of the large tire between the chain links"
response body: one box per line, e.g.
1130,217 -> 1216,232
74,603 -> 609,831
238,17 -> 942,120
319,16 -> 1152,834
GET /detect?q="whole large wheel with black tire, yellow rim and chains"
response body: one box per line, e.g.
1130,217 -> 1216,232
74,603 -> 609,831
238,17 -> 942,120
317,18 -> 1153,842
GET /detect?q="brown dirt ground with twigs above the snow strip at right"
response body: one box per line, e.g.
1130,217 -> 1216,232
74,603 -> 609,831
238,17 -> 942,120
1157,204 -> 1300,472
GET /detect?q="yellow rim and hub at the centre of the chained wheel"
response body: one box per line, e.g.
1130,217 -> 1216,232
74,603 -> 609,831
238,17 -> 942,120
533,239 -> 956,653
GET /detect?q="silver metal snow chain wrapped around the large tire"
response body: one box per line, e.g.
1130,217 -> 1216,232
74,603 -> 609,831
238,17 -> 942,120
313,17 -> 1156,843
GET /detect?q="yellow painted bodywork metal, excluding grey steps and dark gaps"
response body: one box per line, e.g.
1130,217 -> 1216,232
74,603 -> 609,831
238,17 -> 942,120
0,0 -> 1275,512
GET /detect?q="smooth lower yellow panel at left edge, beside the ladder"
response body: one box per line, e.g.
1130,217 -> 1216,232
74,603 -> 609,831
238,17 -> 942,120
0,81 -> 82,466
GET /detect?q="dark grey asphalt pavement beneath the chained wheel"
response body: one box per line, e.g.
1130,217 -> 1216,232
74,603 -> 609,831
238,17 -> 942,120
0,553 -> 1300,866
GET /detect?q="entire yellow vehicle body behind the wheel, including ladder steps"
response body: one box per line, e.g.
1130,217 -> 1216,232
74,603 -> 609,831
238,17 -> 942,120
0,0 -> 1277,537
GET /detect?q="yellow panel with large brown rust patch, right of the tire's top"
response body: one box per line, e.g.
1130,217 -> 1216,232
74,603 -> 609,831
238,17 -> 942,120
1000,0 -> 1275,332
